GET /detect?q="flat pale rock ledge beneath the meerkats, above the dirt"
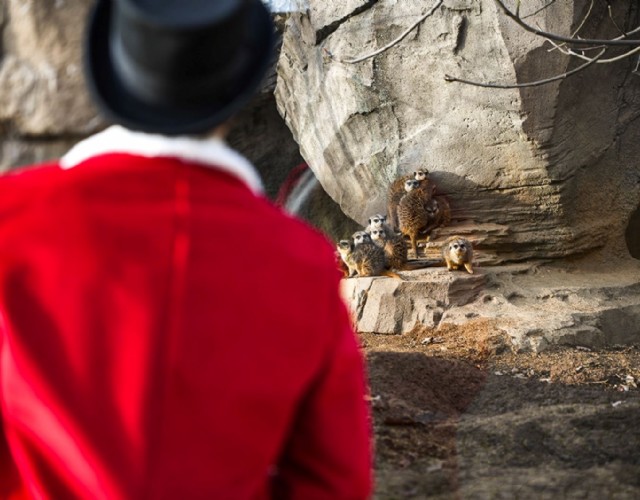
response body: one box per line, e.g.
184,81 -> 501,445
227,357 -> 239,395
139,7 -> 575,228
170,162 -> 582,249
343,261 -> 640,352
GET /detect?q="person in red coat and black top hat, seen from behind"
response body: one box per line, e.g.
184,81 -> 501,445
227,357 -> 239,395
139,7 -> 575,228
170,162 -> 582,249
0,0 -> 372,500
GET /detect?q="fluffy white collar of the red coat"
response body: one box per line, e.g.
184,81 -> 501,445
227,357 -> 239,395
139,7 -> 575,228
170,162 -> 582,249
60,125 -> 263,193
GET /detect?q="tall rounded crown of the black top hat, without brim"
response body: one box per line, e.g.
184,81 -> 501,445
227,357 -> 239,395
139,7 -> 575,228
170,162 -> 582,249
111,0 -> 251,106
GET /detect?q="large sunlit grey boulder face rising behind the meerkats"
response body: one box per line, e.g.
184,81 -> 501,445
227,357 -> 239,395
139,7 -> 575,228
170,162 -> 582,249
276,0 -> 640,262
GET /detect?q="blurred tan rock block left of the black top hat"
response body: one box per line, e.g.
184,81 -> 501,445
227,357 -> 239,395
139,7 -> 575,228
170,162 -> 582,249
0,0 -> 104,136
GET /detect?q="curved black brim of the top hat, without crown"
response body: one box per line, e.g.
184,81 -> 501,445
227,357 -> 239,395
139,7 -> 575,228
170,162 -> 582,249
84,0 -> 275,135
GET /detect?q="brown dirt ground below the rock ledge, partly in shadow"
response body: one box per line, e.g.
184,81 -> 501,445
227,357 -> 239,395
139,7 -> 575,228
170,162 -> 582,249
360,320 -> 640,500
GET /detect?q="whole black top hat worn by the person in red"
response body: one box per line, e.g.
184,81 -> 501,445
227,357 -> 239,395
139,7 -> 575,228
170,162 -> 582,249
85,0 -> 275,135
